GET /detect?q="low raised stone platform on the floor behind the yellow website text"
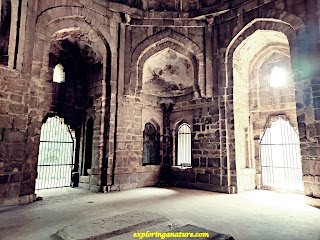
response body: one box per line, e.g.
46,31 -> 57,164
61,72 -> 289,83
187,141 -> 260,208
53,211 -> 234,240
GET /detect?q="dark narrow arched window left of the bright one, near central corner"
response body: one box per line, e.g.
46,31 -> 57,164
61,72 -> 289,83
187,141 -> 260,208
142,123 -> 160,165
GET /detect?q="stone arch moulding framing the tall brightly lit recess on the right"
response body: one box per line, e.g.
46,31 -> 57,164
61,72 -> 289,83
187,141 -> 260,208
218,9 -> 306,193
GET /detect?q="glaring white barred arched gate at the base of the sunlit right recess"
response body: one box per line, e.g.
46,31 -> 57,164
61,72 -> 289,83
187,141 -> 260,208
260,115 -> 303,191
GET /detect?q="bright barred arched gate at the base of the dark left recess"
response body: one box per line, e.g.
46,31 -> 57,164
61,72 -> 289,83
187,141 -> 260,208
35,116 -> 75,190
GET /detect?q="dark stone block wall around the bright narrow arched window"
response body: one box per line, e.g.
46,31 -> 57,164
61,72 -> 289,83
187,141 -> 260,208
171,98 -> 230,192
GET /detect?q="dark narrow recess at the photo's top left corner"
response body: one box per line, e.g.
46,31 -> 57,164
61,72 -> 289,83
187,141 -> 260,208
0,0 -> 11,65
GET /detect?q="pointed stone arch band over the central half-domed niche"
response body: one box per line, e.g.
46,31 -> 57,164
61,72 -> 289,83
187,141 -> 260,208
129,29 -> 205,97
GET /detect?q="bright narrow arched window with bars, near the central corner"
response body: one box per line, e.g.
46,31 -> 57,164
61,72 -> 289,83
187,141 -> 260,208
177,123 -> 191,166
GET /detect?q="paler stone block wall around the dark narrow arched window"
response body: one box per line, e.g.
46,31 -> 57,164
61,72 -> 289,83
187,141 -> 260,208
108,96 -> 162,191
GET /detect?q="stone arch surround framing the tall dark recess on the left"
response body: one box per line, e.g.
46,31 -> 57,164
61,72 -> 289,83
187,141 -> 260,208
32,6 -> 116,191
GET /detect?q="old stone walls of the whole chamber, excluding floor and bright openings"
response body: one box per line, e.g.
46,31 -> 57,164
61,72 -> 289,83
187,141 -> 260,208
0,0 -> 320,206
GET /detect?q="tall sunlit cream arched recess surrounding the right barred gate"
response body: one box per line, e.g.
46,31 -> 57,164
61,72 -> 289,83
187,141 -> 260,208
232,30 -> 301,192
